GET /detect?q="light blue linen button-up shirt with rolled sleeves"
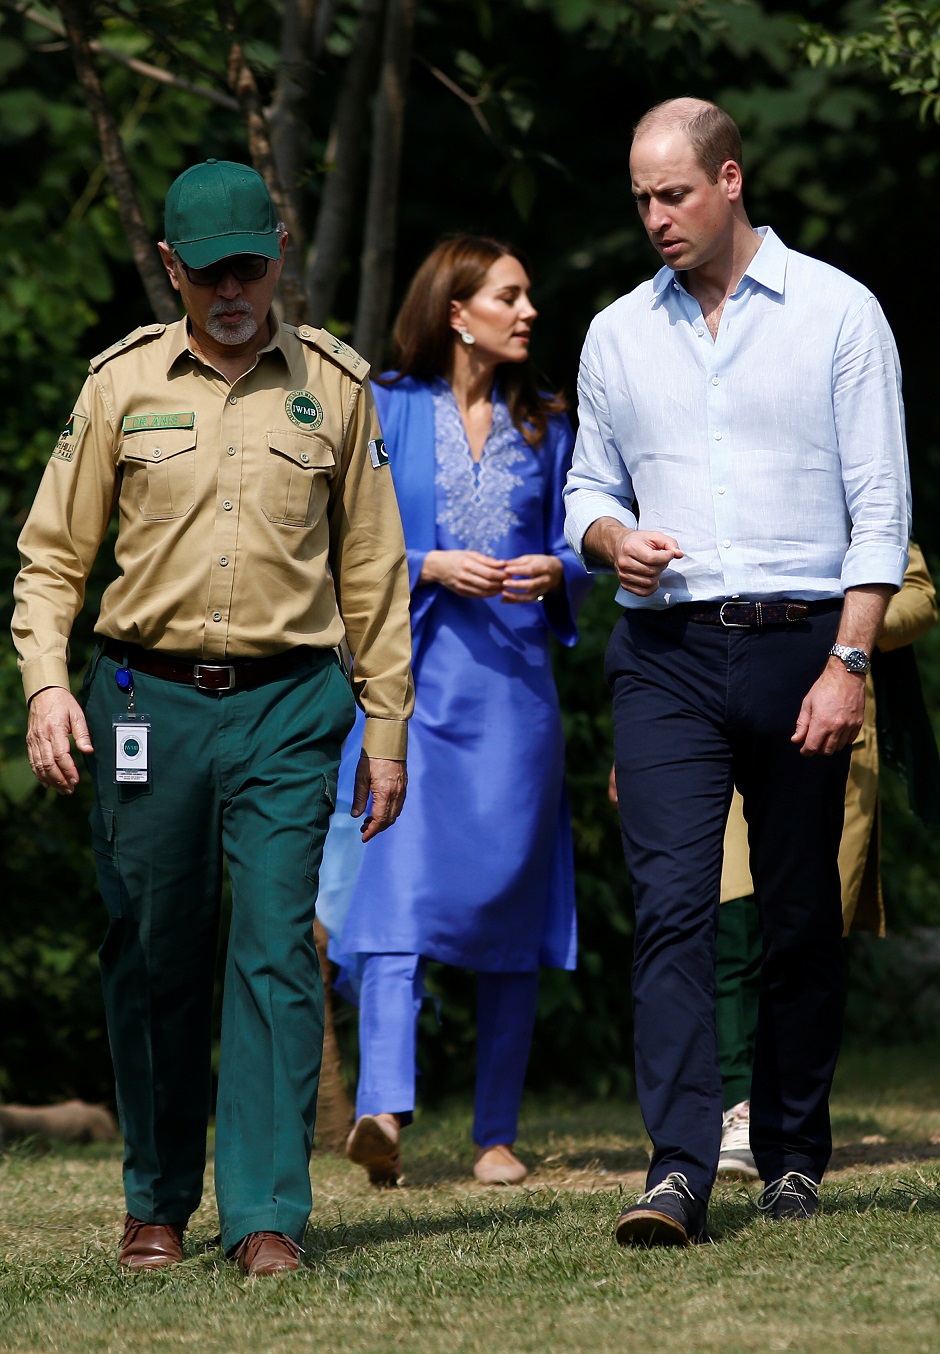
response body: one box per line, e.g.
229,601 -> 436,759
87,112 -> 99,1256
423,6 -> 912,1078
565,227 -> 910,608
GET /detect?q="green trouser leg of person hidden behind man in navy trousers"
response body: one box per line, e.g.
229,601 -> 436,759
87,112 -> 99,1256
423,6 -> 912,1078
715,895 -> 764,1110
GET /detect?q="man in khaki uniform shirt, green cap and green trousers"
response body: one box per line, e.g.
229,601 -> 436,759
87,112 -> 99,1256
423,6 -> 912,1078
14,160 -> 413,1274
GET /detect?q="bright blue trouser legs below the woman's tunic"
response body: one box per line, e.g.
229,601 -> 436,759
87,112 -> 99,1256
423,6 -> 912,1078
356,955 -> 539,1147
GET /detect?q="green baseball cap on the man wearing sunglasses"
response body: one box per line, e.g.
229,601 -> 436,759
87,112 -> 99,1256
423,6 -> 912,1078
165,160 -> 280,268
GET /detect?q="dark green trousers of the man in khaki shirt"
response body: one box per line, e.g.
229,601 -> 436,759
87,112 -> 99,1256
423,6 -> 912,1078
87,653 -> 354,1248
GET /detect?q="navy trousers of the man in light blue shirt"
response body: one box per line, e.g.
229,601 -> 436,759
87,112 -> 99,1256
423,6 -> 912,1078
607,601 -> 851,1200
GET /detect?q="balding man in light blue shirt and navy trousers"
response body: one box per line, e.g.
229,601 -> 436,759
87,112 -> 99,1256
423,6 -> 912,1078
565,99 -> 910,1244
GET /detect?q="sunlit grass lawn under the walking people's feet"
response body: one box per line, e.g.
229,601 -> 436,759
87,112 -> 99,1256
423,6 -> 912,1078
0,1044 -> 940,1354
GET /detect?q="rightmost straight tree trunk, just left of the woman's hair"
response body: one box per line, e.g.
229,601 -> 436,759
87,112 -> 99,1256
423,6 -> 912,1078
354,0 -> 414,362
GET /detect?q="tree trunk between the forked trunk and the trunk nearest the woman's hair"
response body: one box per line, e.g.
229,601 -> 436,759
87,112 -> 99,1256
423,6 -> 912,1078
306,0 -> 385,325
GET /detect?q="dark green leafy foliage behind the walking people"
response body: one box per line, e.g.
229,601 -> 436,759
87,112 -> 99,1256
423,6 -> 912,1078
0,0 -> 940,1099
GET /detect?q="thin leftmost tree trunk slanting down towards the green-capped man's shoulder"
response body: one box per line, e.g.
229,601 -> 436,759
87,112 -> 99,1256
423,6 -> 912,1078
58,0 -> 180,325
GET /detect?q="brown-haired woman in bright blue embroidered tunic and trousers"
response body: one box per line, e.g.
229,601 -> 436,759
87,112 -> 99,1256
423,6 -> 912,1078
333,236 -> 589,1183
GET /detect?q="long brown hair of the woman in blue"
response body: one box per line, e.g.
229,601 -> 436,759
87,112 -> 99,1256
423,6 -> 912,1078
385,236 -> 568,447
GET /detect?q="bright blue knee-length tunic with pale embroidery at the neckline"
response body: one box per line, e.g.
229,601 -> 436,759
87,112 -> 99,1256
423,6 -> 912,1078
330,379 -> 591,978
